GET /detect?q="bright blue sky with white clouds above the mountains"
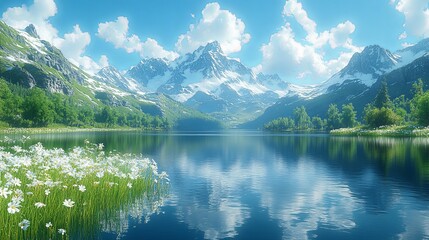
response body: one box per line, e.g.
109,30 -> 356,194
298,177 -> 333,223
0,0 -> 429,84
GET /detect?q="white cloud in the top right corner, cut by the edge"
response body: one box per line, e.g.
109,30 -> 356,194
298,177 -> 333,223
393,0 -> 429,37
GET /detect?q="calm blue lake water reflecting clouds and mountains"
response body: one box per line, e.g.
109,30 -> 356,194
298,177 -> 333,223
10,132 -> 429,239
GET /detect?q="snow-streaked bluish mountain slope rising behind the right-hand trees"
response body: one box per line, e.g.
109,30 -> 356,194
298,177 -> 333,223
242,39 -> 429,128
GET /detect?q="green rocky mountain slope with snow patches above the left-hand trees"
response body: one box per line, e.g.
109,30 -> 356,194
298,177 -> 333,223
0,21 -> 214,126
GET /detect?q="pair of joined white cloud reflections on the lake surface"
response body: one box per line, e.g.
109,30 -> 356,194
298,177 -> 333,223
169,151 -> 358,239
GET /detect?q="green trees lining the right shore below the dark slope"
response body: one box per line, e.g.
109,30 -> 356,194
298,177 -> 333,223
264,79 -> 429,131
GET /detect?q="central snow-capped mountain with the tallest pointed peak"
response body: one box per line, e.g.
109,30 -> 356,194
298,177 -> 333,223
127,41 -> 290,120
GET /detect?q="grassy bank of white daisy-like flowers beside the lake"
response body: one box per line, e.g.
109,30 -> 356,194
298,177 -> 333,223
0,138 -> 169,239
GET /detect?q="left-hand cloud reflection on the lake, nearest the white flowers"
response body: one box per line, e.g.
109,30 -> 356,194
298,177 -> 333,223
172,157 -> 250,239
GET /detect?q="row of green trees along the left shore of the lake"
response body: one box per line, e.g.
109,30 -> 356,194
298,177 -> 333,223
0,79 -> 170,129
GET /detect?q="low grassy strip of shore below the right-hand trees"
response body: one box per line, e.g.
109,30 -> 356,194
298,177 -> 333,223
330,126 -> 429,137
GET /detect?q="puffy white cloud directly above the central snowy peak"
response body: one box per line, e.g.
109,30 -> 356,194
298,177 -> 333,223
176,2 -> 250,54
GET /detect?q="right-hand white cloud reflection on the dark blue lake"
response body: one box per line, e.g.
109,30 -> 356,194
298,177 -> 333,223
254,160 -> 359,239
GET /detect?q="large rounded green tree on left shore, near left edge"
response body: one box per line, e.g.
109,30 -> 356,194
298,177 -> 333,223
22,88 -> 54,127
